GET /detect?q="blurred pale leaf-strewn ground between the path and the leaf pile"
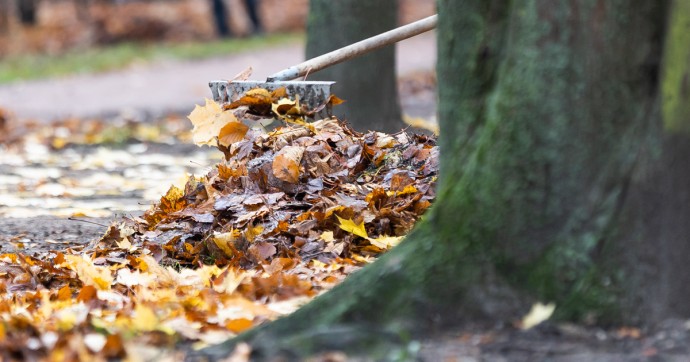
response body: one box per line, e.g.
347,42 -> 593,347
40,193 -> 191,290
0,113 -> 222,218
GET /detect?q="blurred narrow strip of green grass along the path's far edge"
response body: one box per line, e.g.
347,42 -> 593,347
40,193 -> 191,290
0,34 -> 304,84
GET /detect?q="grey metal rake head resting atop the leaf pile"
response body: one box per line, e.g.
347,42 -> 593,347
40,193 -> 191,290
208,80 -> 335,116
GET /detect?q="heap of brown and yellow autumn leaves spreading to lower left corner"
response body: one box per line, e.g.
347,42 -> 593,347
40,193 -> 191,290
0,89 -> 438,360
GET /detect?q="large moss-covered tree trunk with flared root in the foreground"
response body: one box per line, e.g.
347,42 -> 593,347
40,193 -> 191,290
191,0 -> 690,356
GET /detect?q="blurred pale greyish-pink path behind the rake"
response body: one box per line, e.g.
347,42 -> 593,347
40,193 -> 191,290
0,33 -> 436,121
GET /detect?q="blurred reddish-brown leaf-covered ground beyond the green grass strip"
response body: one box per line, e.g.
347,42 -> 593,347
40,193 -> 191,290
0,0 -> 435,53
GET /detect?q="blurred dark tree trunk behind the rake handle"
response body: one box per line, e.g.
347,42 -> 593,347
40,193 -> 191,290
306,0 -> 405,132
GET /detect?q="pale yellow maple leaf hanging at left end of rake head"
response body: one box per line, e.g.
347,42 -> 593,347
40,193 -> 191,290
187,98 -> 239,146
